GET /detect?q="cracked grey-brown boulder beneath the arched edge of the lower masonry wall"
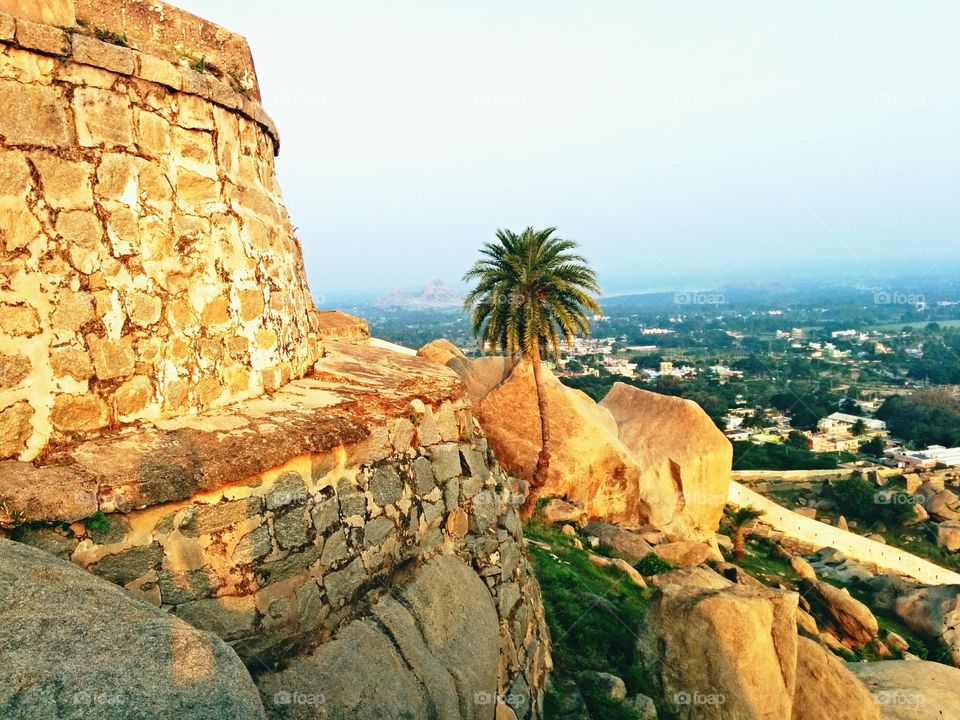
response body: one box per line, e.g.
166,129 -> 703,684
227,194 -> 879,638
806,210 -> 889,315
258,556 -> 499,720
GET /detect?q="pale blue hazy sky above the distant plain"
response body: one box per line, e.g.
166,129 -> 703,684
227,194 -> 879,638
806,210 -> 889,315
182,0 -> 960,296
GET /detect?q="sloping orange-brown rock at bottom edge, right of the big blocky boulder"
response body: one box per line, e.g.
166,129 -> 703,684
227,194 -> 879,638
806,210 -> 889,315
793,637 -> 880,720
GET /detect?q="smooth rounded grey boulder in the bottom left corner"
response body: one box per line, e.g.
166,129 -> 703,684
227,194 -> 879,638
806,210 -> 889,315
0,538 -> 264,720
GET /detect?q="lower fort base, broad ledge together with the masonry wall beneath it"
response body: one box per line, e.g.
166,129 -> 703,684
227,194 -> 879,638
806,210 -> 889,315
0,342 -> 550,718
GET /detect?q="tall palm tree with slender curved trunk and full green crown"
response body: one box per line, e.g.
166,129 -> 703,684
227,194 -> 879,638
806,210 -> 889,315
463,227 -> 601,505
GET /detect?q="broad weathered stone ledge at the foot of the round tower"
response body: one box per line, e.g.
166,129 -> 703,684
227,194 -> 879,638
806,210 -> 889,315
0,342 -> 465,522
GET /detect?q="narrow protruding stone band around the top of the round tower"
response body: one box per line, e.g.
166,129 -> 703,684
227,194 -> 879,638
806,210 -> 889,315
0,12 -> 280,155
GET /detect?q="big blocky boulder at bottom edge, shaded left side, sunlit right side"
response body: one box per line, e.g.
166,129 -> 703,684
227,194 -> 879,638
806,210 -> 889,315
637,585 -> 797,720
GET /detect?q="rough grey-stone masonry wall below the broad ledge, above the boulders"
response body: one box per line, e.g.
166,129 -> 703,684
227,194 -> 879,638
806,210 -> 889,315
17,400 -> 551,718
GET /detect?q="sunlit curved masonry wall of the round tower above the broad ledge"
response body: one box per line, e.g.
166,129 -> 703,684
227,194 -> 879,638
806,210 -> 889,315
0,11 -> 322,460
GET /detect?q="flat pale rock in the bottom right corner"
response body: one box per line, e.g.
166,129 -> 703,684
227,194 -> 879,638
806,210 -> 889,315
847,660 -> 960,720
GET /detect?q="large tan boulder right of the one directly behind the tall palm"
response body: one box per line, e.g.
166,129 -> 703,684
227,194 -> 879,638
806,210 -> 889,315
600,383 -> 733,529
